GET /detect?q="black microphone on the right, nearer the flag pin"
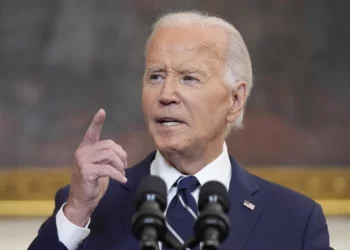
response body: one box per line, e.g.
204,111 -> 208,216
191,181 -> 230,250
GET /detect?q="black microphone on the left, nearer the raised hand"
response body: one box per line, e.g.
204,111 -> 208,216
132,175 -> 181,250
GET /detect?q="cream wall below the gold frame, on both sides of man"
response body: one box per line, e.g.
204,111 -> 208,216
0,217 -> 350,250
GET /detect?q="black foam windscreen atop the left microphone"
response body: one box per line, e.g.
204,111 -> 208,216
136,175 -> 167,211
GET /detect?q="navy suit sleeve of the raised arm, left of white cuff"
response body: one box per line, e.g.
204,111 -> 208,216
28,186 -> 80,250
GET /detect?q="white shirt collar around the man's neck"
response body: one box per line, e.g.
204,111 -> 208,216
151,142 -> 231,192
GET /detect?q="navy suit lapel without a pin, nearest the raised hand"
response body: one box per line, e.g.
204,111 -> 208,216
115,152 -> 155,249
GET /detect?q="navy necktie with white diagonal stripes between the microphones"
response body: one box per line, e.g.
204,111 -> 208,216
163,176 -> 200,250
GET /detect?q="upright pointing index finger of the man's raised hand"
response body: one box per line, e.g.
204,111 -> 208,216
80,109 -> 106,145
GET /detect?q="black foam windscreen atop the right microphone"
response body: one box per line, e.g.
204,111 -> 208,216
198,181 -> 230,213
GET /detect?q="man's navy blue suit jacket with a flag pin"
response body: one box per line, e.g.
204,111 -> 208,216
29,153 -> 332,250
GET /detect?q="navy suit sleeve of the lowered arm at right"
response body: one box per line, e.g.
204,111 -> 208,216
303,203 -> 333,250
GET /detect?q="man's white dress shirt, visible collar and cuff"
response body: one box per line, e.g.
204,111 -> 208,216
56,143 -> 231,250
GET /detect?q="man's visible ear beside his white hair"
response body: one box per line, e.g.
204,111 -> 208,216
227,81 -> 247,123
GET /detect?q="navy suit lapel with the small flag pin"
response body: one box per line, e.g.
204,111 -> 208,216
222,158 -> 263,250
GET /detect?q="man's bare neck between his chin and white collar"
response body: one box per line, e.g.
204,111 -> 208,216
160,141 -> 224,175
